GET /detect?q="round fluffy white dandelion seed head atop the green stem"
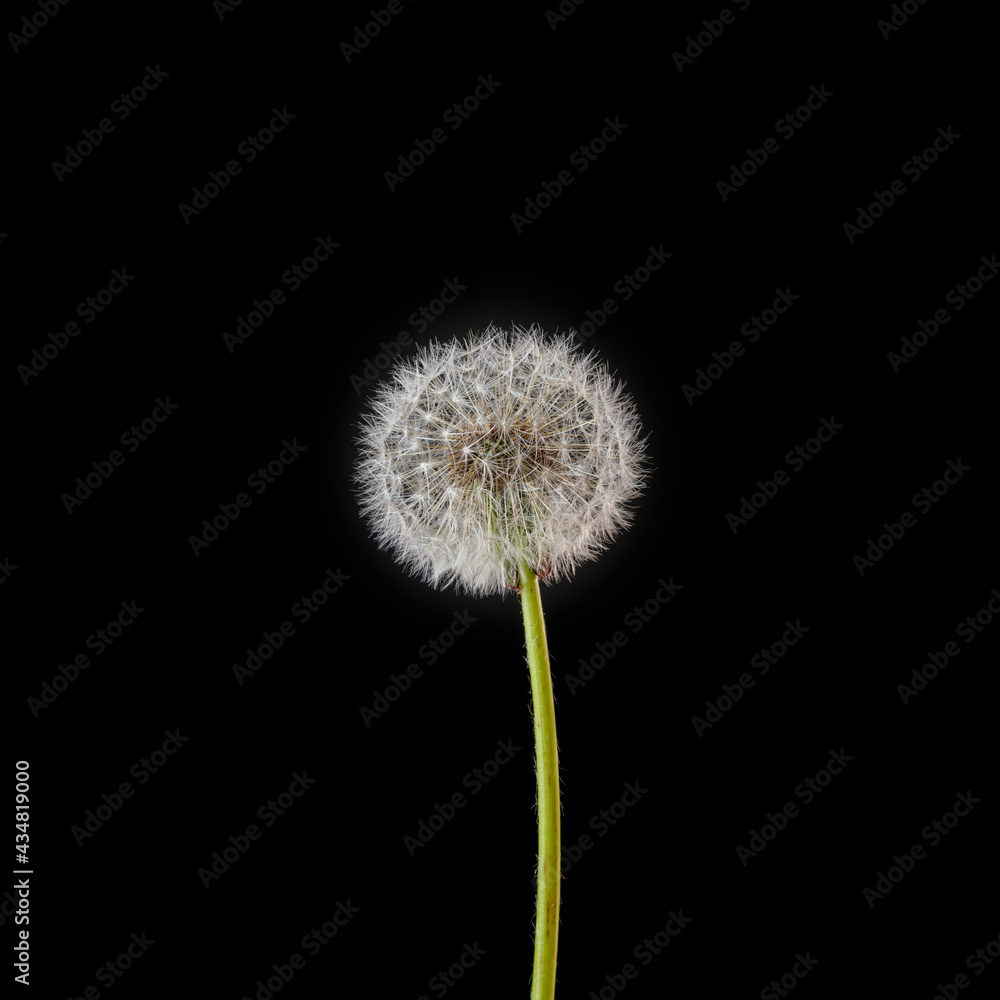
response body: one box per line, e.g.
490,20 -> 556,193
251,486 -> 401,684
355,326 -> 647,595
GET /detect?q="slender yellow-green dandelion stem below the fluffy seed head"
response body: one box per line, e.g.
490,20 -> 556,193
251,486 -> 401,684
520,563 -> 562,1000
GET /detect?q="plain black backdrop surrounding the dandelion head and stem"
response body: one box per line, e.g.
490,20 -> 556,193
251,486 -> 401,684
0,0 -> 1000,1000
